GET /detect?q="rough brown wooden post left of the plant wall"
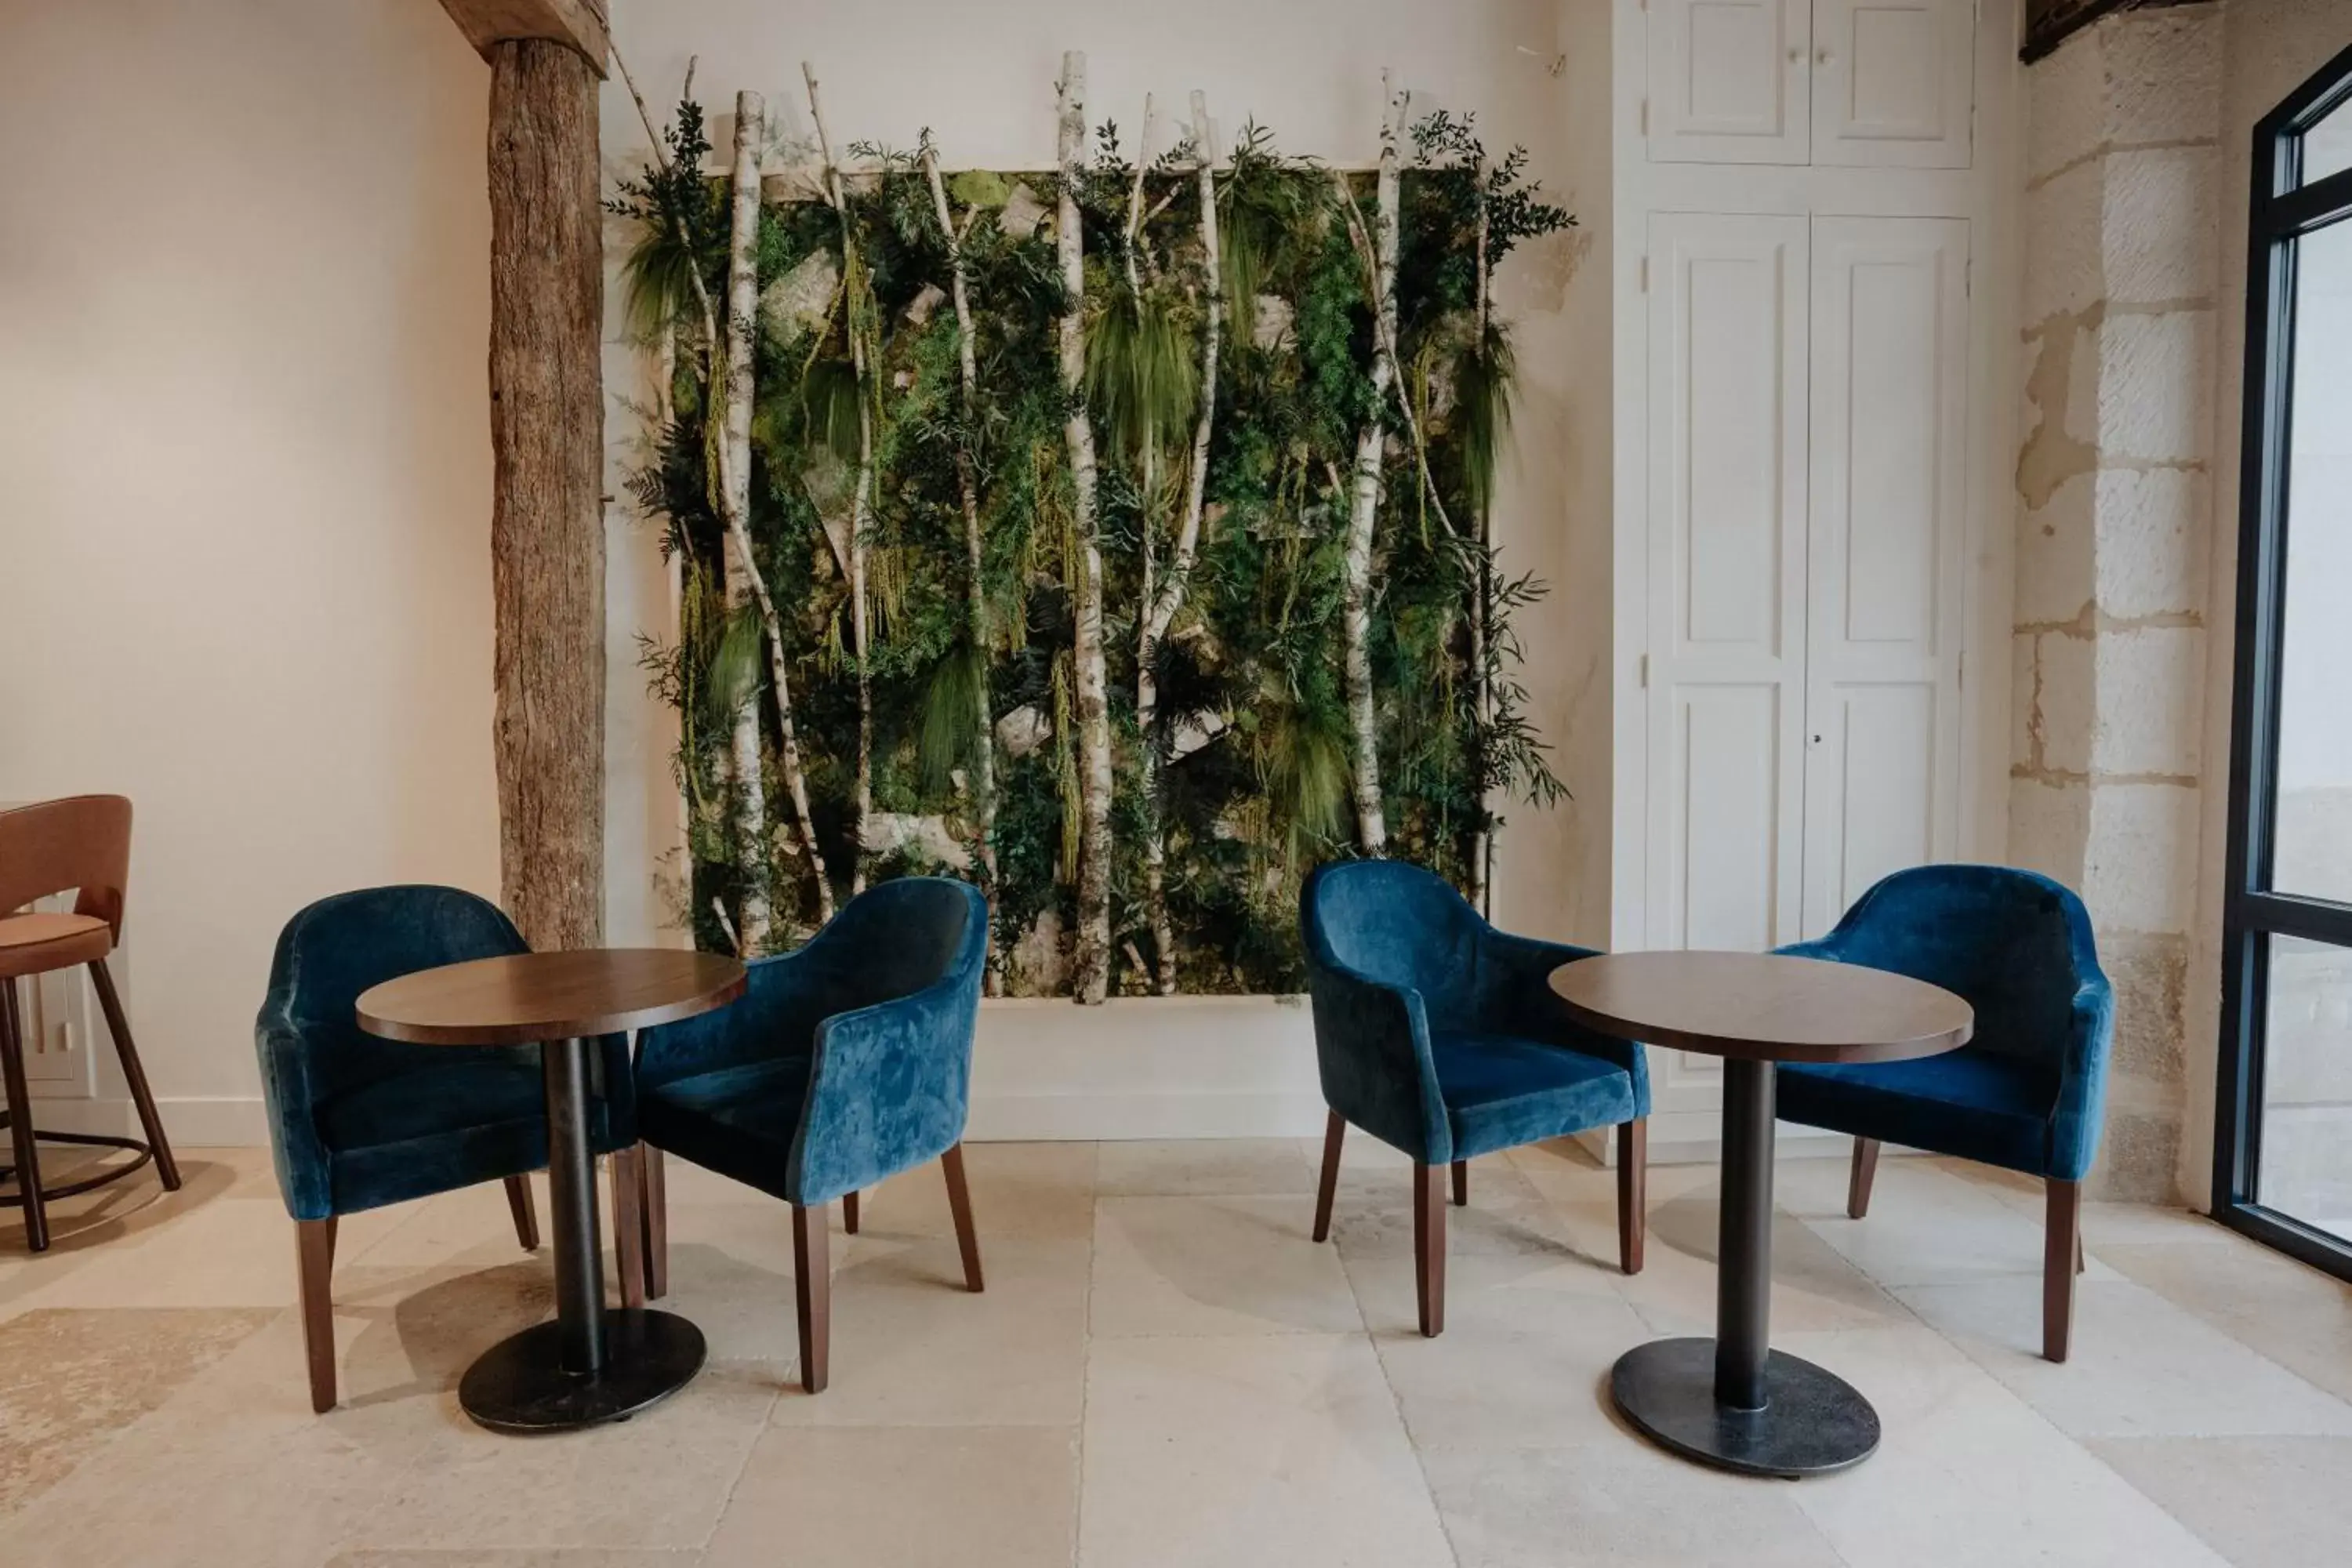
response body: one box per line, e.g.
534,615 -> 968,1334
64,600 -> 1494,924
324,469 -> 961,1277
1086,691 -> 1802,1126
442,0 -> 607,947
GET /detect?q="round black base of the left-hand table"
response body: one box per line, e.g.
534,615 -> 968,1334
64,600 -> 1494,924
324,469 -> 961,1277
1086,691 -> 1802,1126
456,1307 -> 706,1432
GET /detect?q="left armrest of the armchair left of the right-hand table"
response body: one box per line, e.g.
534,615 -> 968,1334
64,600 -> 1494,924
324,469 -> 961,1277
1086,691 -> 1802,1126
1308,954 -> 1454,1163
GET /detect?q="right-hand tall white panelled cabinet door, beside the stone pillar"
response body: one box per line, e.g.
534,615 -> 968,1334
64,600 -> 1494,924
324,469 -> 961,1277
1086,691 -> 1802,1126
1804,219 -> 1969,935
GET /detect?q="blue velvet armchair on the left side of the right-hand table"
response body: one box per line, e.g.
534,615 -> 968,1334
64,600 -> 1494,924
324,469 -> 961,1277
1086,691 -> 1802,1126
1298,860 -> 1649,1335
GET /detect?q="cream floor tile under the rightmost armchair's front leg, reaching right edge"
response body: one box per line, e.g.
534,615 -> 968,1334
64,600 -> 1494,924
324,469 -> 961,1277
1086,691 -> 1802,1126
1896,1279 -> 2352,1436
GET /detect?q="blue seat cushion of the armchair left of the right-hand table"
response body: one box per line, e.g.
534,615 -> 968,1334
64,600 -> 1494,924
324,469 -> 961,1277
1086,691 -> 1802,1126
1430,1029 -> 1642,1159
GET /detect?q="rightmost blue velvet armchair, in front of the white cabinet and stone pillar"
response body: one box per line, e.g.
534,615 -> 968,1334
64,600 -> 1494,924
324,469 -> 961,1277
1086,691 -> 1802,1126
1778,865 -> 2114,1361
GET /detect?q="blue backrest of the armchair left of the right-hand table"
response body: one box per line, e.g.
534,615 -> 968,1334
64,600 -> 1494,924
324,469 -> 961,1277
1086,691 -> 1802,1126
1298,860 -> 1486,1020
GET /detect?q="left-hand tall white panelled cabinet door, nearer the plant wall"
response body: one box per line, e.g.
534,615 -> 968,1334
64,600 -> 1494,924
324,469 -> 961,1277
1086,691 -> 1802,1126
1646,212 -> 1809,949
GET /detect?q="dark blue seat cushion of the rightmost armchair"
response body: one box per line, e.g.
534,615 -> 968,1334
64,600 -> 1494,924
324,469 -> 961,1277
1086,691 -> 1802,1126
1778,1046 -> 2058,1175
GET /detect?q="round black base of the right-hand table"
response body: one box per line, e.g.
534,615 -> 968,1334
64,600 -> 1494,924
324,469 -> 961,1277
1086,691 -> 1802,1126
1609,1340 -> 1879,1479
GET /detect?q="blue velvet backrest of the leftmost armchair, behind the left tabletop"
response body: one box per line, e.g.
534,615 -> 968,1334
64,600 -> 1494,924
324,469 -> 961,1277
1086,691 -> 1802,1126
263,884 -> 529,1100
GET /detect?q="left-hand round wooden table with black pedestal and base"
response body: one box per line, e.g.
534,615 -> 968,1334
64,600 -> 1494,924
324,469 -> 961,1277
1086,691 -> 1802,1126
358,947 -> 746,1432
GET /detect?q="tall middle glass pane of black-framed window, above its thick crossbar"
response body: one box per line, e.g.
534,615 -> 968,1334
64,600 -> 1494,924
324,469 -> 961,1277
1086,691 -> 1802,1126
2270,223 -> 2352,902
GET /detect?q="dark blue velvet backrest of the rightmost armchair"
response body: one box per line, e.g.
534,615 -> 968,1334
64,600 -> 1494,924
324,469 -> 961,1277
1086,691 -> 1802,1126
1825,865 -> 2098,1067
